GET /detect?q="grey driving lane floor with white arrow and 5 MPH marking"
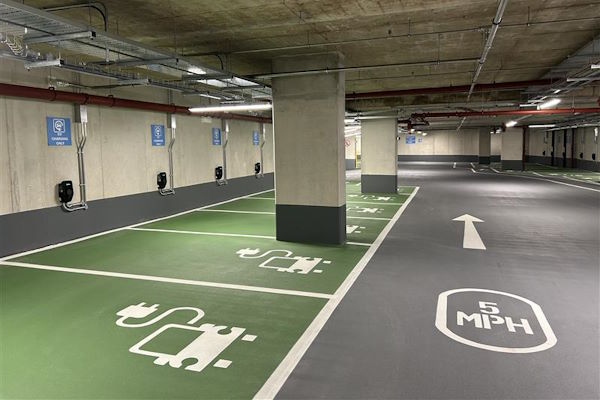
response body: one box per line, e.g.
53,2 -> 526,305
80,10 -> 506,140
277,165 -> 600,399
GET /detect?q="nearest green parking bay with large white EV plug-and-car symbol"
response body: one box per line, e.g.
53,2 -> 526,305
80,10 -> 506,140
0,266 -> 326,399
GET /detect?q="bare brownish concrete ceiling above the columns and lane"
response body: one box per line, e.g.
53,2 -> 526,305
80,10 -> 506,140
17,0 -> 600,123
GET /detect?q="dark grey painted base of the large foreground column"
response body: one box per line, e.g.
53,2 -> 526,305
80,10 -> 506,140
275,204 -> 346,244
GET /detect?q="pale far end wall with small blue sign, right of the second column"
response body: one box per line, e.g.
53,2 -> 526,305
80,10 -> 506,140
398,129 -> 479,162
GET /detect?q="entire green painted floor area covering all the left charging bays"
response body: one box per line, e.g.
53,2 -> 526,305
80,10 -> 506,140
0,186 -> 418,399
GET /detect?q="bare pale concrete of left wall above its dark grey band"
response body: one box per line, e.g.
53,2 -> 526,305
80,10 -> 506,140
0,56 -> 273,215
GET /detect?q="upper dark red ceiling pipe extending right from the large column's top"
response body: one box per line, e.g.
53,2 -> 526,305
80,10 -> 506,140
346,79 -> 554,100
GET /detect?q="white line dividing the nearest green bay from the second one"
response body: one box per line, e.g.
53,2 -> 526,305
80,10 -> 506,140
0,261 -> 334,299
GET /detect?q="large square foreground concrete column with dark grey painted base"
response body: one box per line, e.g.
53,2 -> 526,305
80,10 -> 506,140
272,53 -> 346,244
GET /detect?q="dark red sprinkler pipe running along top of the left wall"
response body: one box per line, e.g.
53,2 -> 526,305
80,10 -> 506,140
0,83 -> 271,123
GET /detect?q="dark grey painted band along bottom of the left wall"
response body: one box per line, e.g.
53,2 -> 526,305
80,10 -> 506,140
0,173 -> 274,256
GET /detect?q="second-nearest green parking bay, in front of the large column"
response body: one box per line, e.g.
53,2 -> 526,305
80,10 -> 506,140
11,229 -> 368,293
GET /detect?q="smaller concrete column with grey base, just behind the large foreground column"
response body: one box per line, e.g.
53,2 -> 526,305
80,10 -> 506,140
360,118 -> 398,193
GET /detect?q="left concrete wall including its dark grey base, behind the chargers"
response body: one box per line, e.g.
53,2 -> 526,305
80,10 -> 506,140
0,59 -> 274,256
